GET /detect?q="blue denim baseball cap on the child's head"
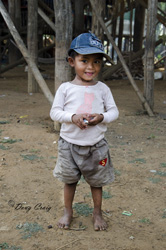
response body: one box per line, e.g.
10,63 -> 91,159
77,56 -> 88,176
68,33 -> 112,61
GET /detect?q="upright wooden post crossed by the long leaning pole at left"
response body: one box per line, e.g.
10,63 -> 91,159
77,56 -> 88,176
27,0 -> 39,93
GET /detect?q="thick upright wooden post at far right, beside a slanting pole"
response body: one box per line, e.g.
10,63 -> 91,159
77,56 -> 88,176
144,0 -> 157,110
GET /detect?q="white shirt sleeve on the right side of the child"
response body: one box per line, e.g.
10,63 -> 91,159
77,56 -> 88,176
102,87 -> 119,123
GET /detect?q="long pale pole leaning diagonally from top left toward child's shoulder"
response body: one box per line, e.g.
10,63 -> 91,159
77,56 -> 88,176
0,0 -> 54,105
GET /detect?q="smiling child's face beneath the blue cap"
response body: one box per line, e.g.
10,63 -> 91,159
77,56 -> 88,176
69,54 -> 102,82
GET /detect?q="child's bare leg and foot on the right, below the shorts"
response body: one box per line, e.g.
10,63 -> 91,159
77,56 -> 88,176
91,187 -> 107,231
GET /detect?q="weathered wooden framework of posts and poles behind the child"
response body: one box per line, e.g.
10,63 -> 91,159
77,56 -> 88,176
0,0 -> 166,116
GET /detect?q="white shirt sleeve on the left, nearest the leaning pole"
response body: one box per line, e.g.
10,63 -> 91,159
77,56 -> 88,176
50,85 -> 74,123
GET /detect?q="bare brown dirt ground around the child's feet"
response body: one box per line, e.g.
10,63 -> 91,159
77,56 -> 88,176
0,66 -> 166,250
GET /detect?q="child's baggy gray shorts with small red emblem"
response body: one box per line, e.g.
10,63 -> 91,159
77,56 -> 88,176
53,138 -> 114,187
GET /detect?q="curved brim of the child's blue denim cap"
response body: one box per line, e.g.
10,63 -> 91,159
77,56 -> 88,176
68,47 -> 114,64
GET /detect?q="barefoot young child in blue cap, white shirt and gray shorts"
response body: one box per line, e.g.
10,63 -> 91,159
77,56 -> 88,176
50,33 -> 119,231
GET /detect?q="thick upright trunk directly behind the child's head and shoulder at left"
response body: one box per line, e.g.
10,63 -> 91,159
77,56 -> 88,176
54,0 -> 73,131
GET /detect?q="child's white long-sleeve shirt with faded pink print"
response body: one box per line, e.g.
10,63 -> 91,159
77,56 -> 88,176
50,81 -> 119,146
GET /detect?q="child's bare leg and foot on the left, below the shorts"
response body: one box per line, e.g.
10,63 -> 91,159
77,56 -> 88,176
58,183 -> 77,229
